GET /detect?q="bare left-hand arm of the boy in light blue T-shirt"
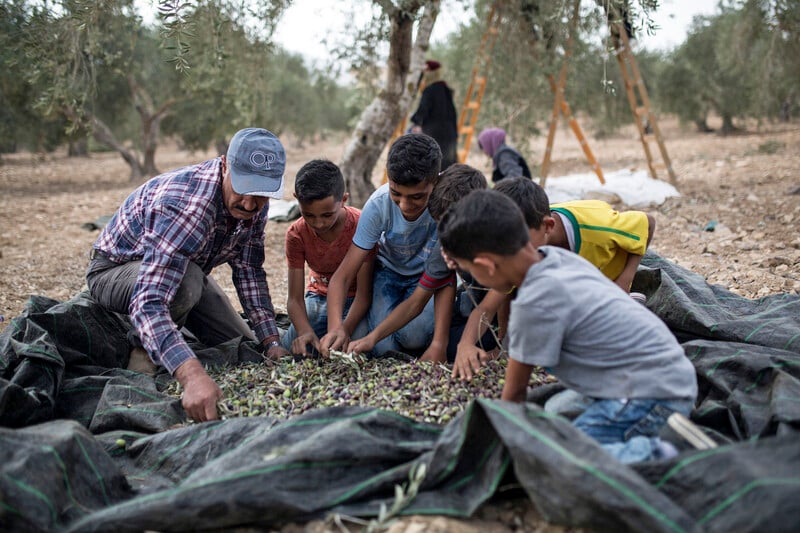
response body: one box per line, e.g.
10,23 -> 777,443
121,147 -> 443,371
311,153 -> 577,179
320,244 -> 369,355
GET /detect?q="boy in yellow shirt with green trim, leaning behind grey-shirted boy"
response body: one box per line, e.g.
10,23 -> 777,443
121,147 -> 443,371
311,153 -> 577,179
453,177 -> 655,380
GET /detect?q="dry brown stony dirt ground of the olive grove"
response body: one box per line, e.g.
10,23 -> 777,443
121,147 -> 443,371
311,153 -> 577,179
0,115 -> 800,533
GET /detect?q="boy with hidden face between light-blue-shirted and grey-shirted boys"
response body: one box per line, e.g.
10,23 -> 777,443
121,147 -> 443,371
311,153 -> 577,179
347,163 -> 488,363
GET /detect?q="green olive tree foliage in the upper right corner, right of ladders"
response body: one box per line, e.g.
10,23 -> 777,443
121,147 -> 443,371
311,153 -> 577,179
658,0 -> 800,131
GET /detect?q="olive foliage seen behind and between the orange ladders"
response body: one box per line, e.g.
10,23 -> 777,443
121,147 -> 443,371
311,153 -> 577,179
435,0 -> 661,150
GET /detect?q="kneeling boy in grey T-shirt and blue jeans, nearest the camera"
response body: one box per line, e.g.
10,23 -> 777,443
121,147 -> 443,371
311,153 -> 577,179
439,191 -> 697,463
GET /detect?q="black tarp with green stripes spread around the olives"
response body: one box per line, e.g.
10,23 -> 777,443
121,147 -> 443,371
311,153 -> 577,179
0,254 -> 800,532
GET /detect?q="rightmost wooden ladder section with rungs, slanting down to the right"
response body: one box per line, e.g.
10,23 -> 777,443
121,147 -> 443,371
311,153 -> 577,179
610,16 -> 677,185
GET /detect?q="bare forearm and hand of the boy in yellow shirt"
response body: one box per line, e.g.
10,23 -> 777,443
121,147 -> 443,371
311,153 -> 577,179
452,290 -> 506,381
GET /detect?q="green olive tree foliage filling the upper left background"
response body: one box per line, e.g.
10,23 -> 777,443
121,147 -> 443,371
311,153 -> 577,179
0,0 -> 357,159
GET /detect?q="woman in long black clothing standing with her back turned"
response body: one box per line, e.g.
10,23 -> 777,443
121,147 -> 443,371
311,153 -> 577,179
411,60 -> 458,170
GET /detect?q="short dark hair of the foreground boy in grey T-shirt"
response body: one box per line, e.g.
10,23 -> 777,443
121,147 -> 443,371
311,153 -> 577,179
439,190 -> 530,261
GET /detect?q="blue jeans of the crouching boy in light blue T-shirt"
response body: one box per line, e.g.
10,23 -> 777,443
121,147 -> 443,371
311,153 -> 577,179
367,265 -> 434,357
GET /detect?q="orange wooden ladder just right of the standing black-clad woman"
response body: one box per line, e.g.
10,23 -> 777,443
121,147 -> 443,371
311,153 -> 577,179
458,0 -> 502,163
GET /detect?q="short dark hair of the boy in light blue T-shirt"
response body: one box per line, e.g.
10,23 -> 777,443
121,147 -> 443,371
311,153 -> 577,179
386,133 -> 442,187
